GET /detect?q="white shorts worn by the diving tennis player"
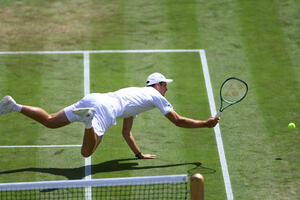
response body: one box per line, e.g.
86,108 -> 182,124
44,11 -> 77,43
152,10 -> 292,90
64,93 -> 114,136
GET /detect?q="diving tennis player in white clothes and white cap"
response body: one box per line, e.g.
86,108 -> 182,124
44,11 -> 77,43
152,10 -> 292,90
0,73 -> 220,159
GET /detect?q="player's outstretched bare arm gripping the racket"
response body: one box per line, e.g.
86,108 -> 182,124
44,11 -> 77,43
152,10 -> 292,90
165,110 -> 220,128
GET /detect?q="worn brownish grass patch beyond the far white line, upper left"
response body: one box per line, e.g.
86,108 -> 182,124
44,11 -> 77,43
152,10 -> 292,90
0,0 -> 118,50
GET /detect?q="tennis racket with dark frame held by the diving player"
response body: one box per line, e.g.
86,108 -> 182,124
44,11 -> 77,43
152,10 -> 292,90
215,77 -> 248,118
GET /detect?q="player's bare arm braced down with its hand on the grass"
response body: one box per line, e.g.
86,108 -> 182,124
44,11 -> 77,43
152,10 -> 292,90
122,117 -> 156,159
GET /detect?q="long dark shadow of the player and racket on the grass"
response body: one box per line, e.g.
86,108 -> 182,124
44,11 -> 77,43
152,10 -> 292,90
0,158 -> 216,180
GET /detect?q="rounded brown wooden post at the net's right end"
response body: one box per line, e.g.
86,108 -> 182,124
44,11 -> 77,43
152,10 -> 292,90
190,173 -> 204,200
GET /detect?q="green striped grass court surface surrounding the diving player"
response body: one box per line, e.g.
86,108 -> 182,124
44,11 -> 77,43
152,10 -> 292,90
0,0 -> 300,200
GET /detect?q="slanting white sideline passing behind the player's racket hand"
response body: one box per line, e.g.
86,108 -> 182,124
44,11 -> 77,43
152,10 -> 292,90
199,50 -> 233,200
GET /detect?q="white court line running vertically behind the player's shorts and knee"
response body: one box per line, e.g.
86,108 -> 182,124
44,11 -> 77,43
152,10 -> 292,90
83,51 -> 92,200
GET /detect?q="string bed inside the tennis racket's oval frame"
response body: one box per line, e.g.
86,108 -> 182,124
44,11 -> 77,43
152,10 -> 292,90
221,79 -> 247,103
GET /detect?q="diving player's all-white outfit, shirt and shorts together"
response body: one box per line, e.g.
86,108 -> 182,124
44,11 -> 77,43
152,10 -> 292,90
65,87 -> 173,135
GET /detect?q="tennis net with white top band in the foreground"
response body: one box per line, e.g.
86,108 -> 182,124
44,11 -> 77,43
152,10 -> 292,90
0,175 -> 188,200
